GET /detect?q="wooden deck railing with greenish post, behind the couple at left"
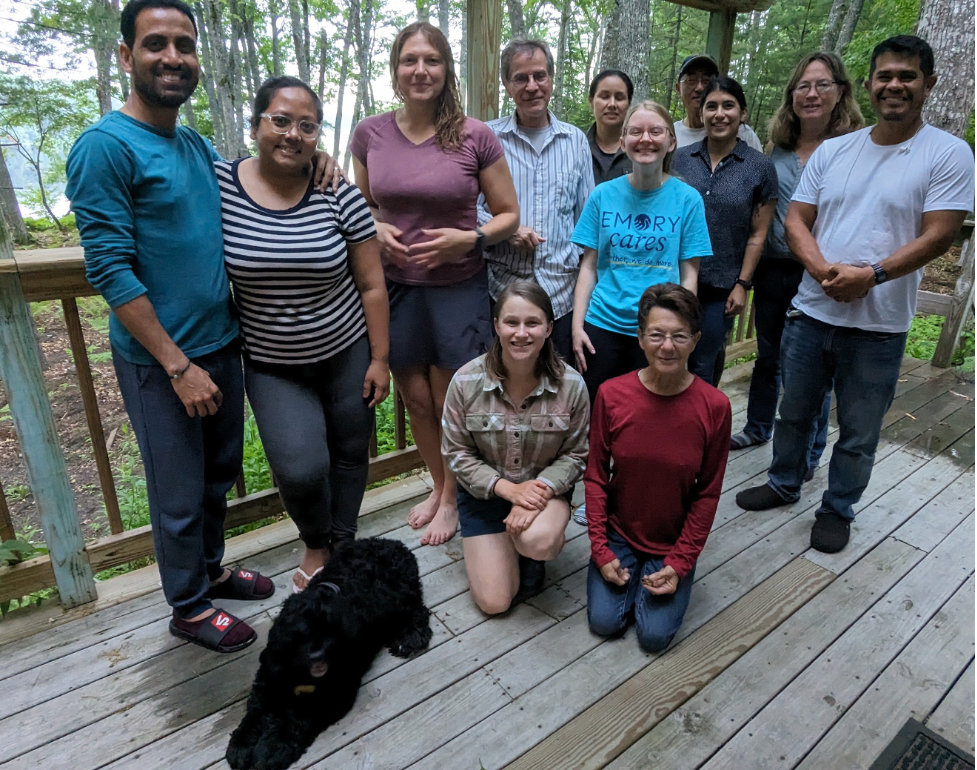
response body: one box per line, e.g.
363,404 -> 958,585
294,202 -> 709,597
0,237 -> 423,607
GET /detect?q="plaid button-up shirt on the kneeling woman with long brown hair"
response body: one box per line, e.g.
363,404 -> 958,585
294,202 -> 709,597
441,356 -> 590,500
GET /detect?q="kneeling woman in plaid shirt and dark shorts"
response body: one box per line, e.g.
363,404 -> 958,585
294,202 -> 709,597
441,281 -> 590,615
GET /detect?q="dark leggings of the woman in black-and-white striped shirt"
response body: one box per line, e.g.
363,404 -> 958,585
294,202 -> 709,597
244,335 -> 373,549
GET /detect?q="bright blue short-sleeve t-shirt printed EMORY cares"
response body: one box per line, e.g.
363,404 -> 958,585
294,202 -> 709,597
571,176 -> 712,336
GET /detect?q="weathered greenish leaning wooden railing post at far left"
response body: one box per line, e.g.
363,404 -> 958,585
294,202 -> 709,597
0,222 -> 98,607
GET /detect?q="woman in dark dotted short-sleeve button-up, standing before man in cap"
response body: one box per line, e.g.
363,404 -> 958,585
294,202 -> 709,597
672,76 -> 777,385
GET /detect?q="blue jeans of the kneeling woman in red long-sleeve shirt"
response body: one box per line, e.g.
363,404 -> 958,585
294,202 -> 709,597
587,527 -> 695,652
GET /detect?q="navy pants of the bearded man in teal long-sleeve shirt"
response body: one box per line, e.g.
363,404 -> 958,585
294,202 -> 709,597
112,341 -> 244,618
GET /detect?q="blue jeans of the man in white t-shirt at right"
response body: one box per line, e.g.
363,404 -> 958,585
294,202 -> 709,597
770,309 -> 906,519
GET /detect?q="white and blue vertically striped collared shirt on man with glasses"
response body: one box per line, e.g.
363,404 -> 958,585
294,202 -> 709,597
479,112 -> 594,318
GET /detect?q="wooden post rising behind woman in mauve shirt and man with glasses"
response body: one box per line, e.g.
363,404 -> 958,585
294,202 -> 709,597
467,0 -> 502,120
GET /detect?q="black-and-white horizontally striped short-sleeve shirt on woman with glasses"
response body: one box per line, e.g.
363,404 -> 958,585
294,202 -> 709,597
214,160 -> 376,364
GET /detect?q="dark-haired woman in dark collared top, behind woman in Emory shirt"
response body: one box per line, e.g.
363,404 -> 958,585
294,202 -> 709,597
587,70 -> 634,184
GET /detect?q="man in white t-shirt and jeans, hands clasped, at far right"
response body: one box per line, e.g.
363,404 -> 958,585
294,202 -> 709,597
736,35 -> 974,553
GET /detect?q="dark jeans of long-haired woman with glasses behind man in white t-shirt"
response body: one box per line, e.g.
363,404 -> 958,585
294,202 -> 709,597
743,259 -> 831,467
